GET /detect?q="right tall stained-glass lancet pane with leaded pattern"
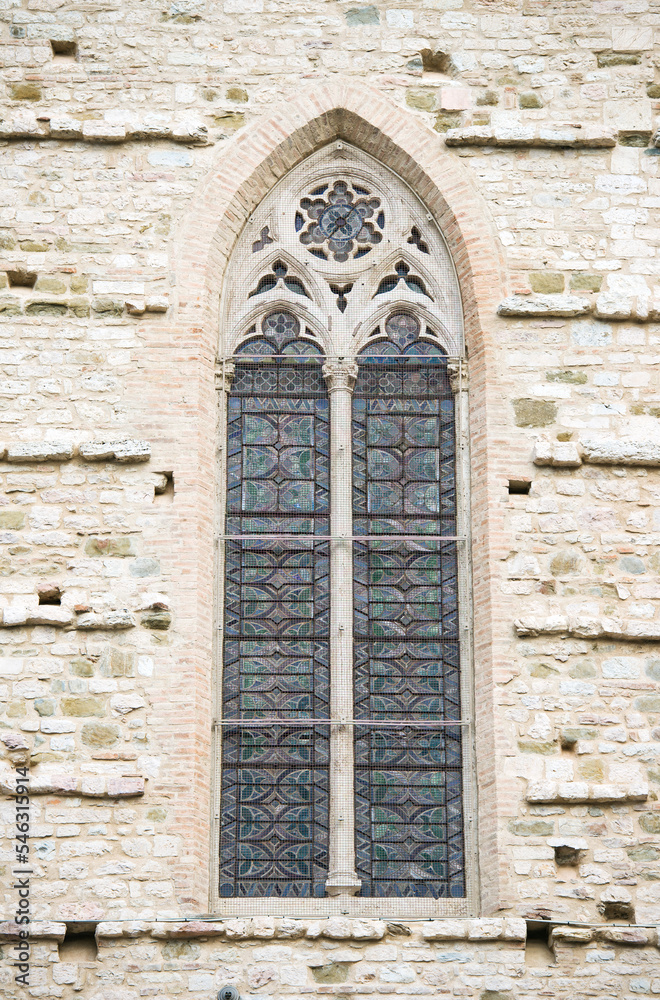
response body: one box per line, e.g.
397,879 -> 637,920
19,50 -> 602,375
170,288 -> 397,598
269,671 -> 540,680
353,313 -> 465,897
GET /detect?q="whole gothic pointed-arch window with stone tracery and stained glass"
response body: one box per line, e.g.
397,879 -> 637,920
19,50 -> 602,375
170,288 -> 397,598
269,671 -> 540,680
216,143 -> 473,915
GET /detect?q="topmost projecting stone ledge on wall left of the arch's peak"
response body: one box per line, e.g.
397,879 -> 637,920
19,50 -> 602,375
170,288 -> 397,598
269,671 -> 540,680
0,110 -> 210,146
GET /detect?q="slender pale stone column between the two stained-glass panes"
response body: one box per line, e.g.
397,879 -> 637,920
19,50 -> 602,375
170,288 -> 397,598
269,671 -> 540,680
323,362 -> 361,896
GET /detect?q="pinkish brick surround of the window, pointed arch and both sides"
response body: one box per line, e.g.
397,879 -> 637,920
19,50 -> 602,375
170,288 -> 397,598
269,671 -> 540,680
170,83 -> 512,913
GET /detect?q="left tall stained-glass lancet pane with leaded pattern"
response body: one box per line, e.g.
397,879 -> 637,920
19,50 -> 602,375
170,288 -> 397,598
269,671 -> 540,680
220,312 -> 329,897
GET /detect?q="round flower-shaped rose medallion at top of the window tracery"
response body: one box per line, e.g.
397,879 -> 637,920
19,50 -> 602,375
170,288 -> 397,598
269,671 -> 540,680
296,181 -> 385,262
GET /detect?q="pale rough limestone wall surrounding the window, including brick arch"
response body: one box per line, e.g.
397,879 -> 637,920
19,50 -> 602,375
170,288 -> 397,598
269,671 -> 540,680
0,0 -> 660,1000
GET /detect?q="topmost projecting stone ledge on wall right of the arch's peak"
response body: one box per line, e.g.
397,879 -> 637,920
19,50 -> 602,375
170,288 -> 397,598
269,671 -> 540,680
445,124 -> 616,149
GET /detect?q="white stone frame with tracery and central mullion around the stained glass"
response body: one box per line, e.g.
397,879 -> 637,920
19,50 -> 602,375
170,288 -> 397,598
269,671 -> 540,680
210,142 -> 479,919
